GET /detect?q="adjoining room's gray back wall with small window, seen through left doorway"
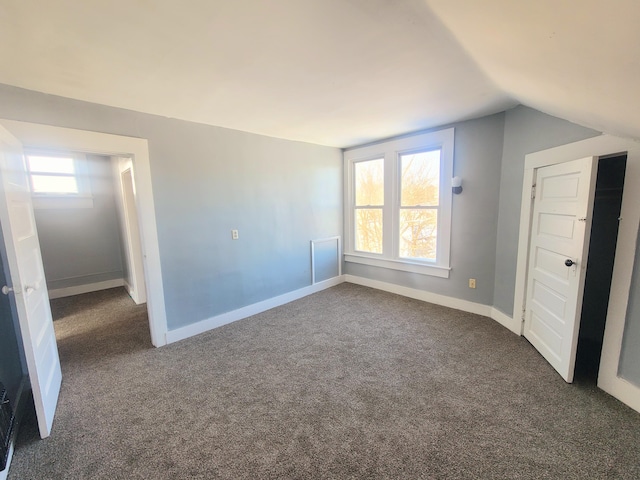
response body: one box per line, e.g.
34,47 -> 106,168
24,147 -> 131,299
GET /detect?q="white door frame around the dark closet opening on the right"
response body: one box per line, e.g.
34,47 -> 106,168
513,135 -> 640,412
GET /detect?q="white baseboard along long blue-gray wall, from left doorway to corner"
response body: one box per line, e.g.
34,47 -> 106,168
166,275 -> 344,344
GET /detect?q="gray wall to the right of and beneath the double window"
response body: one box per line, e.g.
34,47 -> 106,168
345,113 -> 504,305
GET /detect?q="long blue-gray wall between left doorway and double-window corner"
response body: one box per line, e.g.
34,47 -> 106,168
0,85 -> 342,330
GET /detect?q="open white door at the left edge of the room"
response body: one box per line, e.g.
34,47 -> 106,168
0,127 -> 62,438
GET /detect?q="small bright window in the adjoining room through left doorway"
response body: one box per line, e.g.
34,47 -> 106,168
25,151 -> 93,208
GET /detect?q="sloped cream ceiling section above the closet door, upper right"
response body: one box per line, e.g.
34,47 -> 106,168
427,0 -> 640,144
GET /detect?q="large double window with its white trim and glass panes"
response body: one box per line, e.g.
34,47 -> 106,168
344,129 -> 454,277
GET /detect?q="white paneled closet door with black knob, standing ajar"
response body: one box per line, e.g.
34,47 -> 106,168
524,157 -> 598,382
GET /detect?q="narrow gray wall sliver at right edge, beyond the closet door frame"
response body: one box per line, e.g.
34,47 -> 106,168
618,227 -> 640,386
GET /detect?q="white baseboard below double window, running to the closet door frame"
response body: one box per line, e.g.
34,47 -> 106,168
344,274 -> 520,335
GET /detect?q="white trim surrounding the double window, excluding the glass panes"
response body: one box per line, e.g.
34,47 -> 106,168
344,128 -> 454,278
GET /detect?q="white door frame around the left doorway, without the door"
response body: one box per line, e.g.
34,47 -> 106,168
0,119 -> 167,347
